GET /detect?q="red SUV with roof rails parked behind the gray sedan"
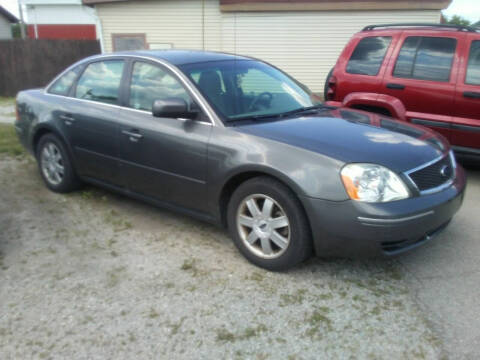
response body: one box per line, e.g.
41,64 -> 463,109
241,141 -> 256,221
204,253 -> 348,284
325,24 -> 480,159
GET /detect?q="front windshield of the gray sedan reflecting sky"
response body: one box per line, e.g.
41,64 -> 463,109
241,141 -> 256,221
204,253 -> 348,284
180,60 -> 321,121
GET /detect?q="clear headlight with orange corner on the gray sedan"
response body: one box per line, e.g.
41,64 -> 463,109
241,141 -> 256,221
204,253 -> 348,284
341,164 -> 410,202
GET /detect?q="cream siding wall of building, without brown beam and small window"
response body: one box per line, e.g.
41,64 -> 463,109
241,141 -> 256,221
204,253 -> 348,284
96,0 -> 440,92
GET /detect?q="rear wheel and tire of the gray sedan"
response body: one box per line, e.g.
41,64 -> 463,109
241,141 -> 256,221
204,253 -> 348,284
36,133 -> 80,193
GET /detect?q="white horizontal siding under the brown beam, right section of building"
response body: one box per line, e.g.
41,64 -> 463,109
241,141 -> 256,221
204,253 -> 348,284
222,10 -> 440,93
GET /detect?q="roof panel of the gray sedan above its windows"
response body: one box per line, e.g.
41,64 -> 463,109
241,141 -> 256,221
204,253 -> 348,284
104,49 -> 253,65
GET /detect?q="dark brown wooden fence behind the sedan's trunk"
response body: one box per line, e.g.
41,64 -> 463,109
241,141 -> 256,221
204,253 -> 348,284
0,39 -> 100,96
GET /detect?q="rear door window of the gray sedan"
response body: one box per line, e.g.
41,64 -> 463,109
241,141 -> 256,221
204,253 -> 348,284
75,60 -> 124,104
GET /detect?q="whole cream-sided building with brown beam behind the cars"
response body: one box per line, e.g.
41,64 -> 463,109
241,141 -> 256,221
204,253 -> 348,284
83,0 -> 451,92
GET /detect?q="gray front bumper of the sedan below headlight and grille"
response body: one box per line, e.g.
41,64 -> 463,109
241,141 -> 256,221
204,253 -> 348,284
301,166 -> 466,258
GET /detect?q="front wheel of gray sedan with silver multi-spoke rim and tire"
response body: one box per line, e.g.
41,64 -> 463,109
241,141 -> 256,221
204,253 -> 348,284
227,176 -> 312,271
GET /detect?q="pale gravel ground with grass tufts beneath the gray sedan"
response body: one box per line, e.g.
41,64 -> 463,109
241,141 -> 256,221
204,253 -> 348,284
0,157 -> 480,359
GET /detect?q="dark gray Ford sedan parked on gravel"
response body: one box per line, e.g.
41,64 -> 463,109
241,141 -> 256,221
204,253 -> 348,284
15,50 -> 465,270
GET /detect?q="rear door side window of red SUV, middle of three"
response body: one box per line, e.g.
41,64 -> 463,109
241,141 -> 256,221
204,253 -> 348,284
393,36 -> 457,81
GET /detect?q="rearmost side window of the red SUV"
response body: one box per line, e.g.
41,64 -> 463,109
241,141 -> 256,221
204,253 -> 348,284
347,36 -> 392,76
